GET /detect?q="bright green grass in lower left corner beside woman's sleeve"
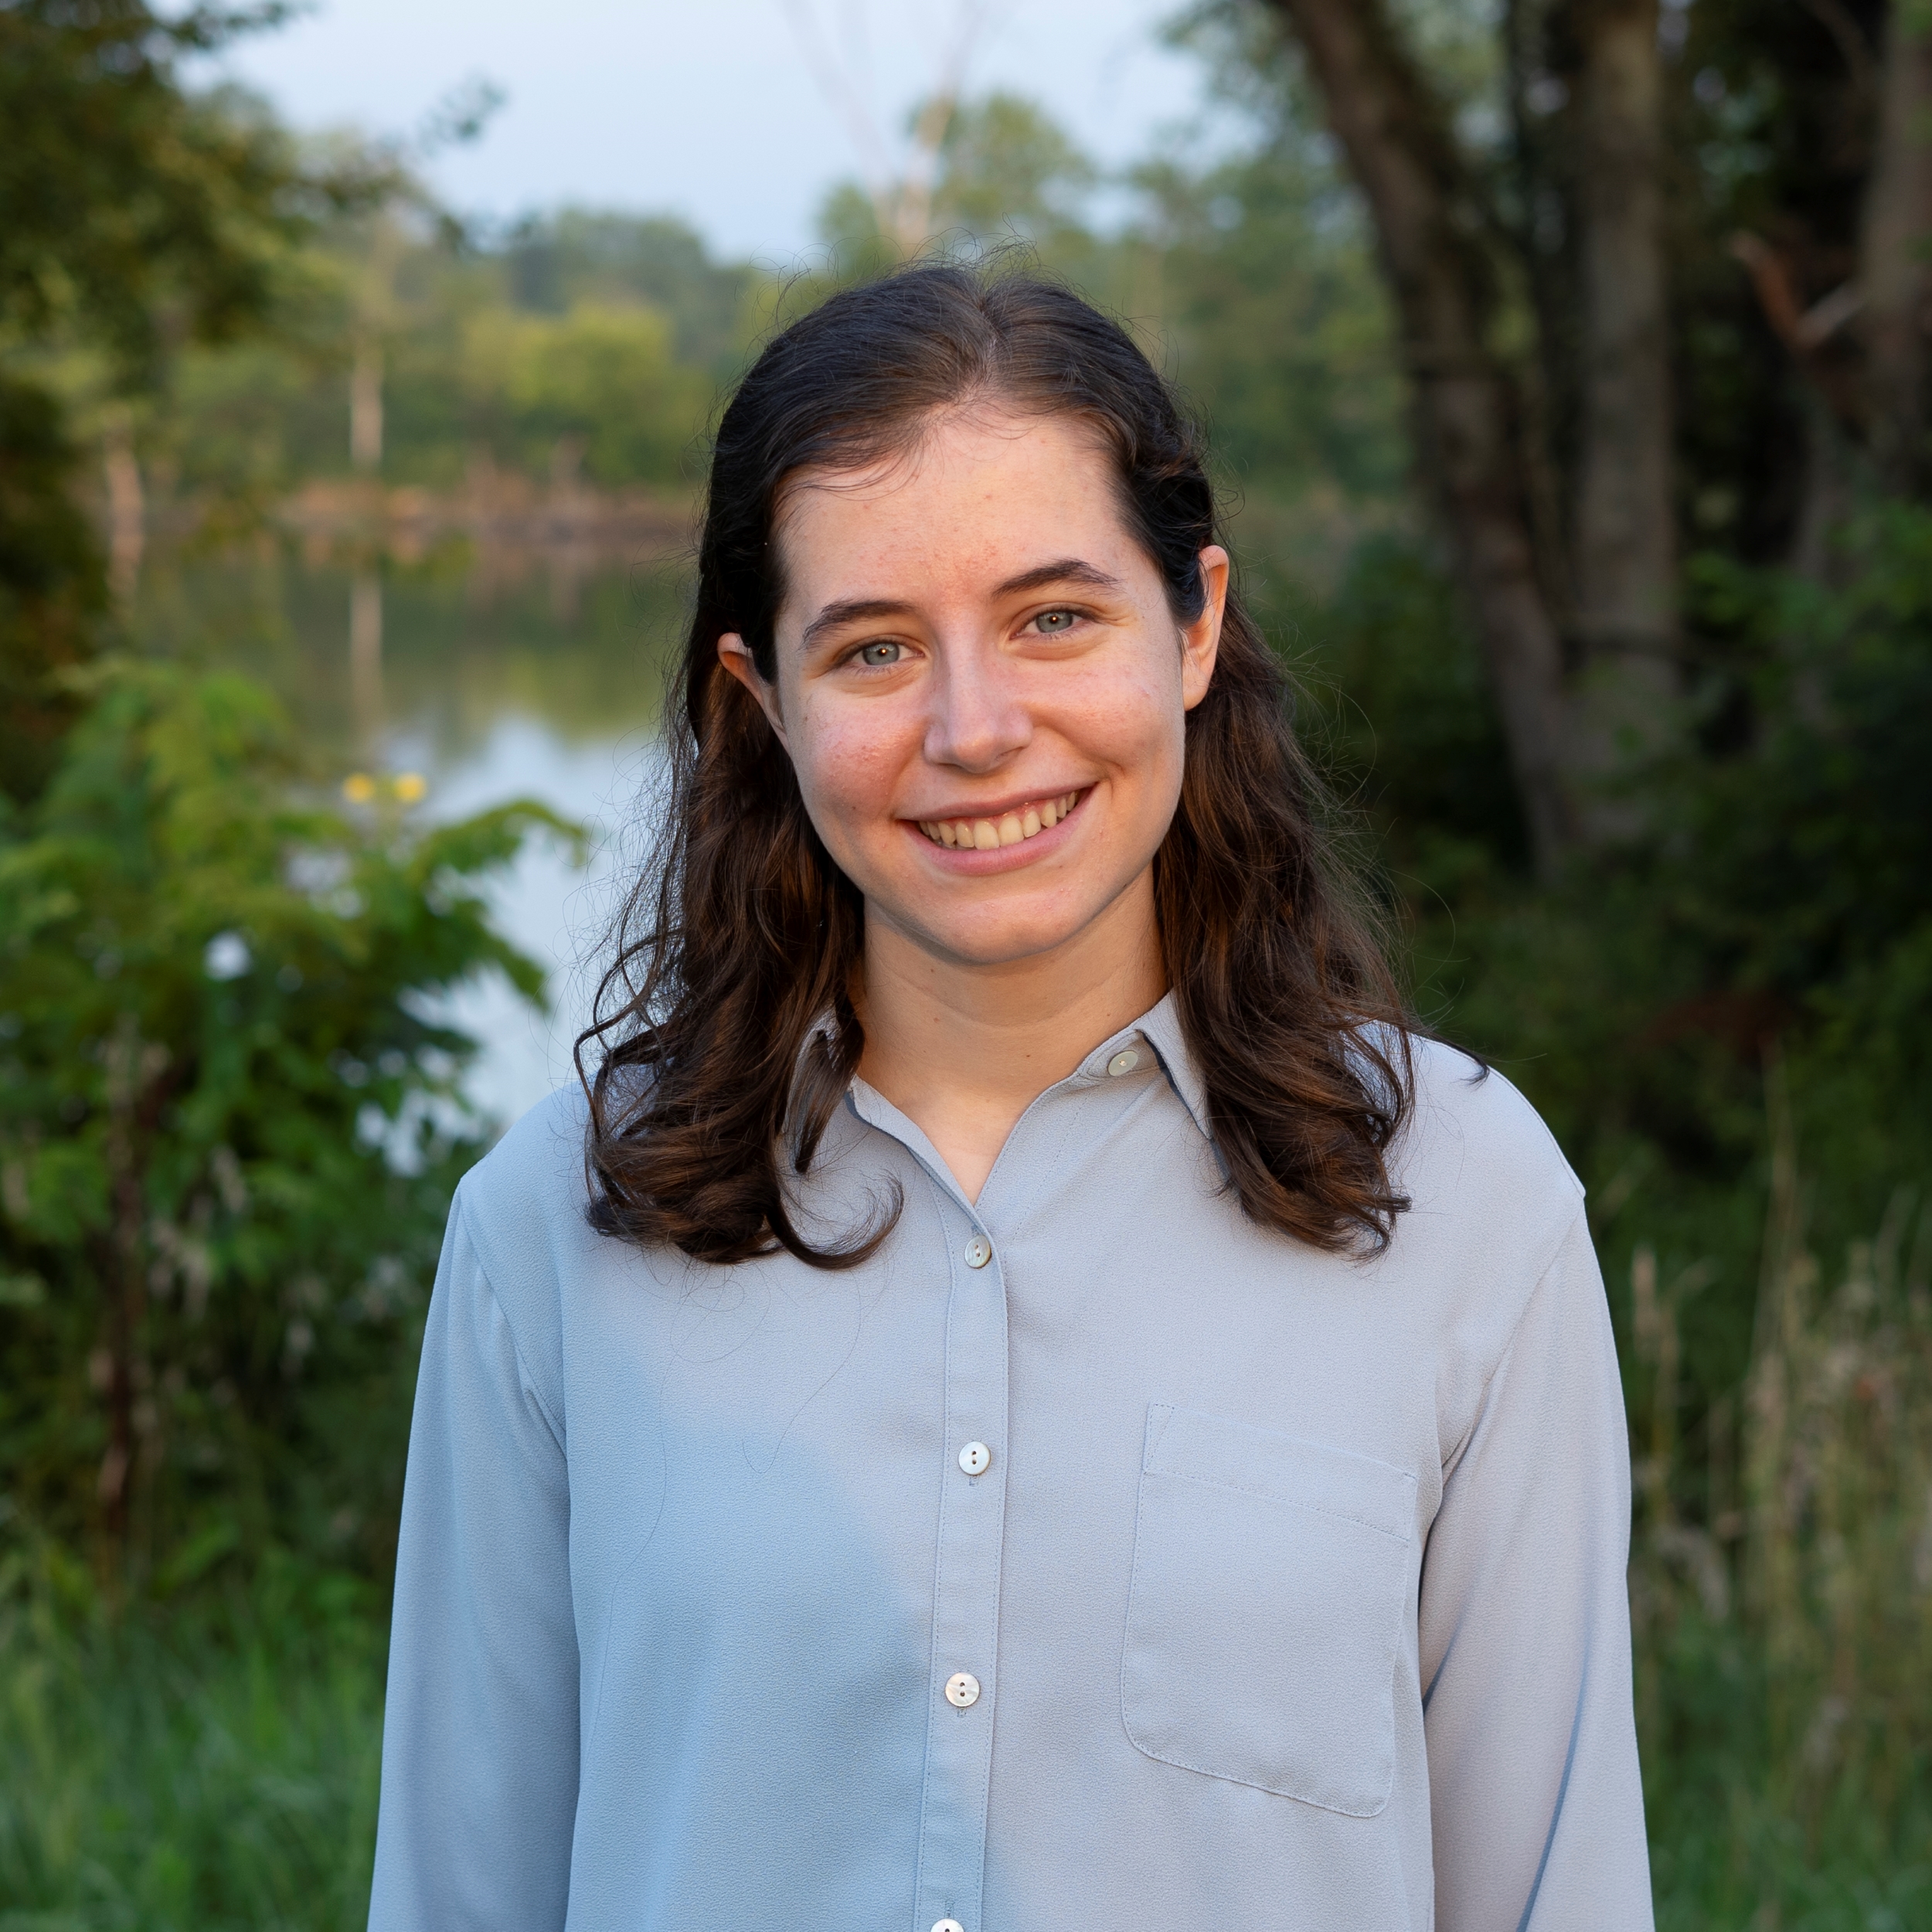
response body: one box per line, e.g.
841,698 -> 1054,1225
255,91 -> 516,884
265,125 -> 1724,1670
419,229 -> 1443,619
0,1556 -> 383,1932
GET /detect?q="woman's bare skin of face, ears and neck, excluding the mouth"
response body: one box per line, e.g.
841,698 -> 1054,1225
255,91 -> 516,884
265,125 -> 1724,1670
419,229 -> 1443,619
719,408 -> 1229,1200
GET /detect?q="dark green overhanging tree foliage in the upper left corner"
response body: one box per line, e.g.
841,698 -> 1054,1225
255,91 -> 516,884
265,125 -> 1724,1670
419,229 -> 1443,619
0,0 -> 380,800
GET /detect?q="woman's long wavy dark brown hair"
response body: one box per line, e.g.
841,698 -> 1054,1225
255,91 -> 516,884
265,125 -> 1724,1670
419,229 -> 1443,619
578,265 -> 1413,1267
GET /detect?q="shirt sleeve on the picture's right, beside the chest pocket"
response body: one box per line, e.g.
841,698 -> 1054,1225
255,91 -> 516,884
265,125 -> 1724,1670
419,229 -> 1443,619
1420,1213 -> 1652,1932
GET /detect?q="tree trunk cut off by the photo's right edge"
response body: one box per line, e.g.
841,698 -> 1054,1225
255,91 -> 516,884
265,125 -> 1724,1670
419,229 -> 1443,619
1859,0 -> 1932,495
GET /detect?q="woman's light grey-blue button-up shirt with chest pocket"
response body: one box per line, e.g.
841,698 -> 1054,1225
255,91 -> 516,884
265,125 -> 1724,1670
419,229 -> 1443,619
371,1001 -> 1650,1932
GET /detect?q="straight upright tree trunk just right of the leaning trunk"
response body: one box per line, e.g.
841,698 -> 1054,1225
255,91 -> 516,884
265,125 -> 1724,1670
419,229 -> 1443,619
1571,0 -> 1677,777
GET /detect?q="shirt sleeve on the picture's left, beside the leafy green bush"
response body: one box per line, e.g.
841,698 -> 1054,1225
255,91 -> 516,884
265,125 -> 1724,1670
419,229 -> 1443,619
369,1196 -> 578,1932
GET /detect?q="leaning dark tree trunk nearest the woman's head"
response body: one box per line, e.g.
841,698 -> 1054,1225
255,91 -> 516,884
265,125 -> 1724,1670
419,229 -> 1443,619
1274,0 -> 1577,876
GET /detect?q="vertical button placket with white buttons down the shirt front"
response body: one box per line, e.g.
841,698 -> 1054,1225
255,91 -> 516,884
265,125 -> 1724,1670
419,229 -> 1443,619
914,1217 -> 1007,1932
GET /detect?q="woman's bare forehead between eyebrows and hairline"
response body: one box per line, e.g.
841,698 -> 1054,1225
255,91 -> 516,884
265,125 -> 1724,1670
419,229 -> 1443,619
773,410 -> 1138,607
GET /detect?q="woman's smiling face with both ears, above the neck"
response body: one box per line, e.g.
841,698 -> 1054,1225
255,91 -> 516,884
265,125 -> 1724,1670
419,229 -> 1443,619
719,412 -> 1227,981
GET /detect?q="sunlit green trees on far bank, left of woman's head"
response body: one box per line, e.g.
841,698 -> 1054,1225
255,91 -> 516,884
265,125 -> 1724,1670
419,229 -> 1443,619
145,211 -> 738,498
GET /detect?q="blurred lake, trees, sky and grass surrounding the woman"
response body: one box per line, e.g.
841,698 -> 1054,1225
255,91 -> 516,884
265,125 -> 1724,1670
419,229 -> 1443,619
0,0 -> 1932,1932
